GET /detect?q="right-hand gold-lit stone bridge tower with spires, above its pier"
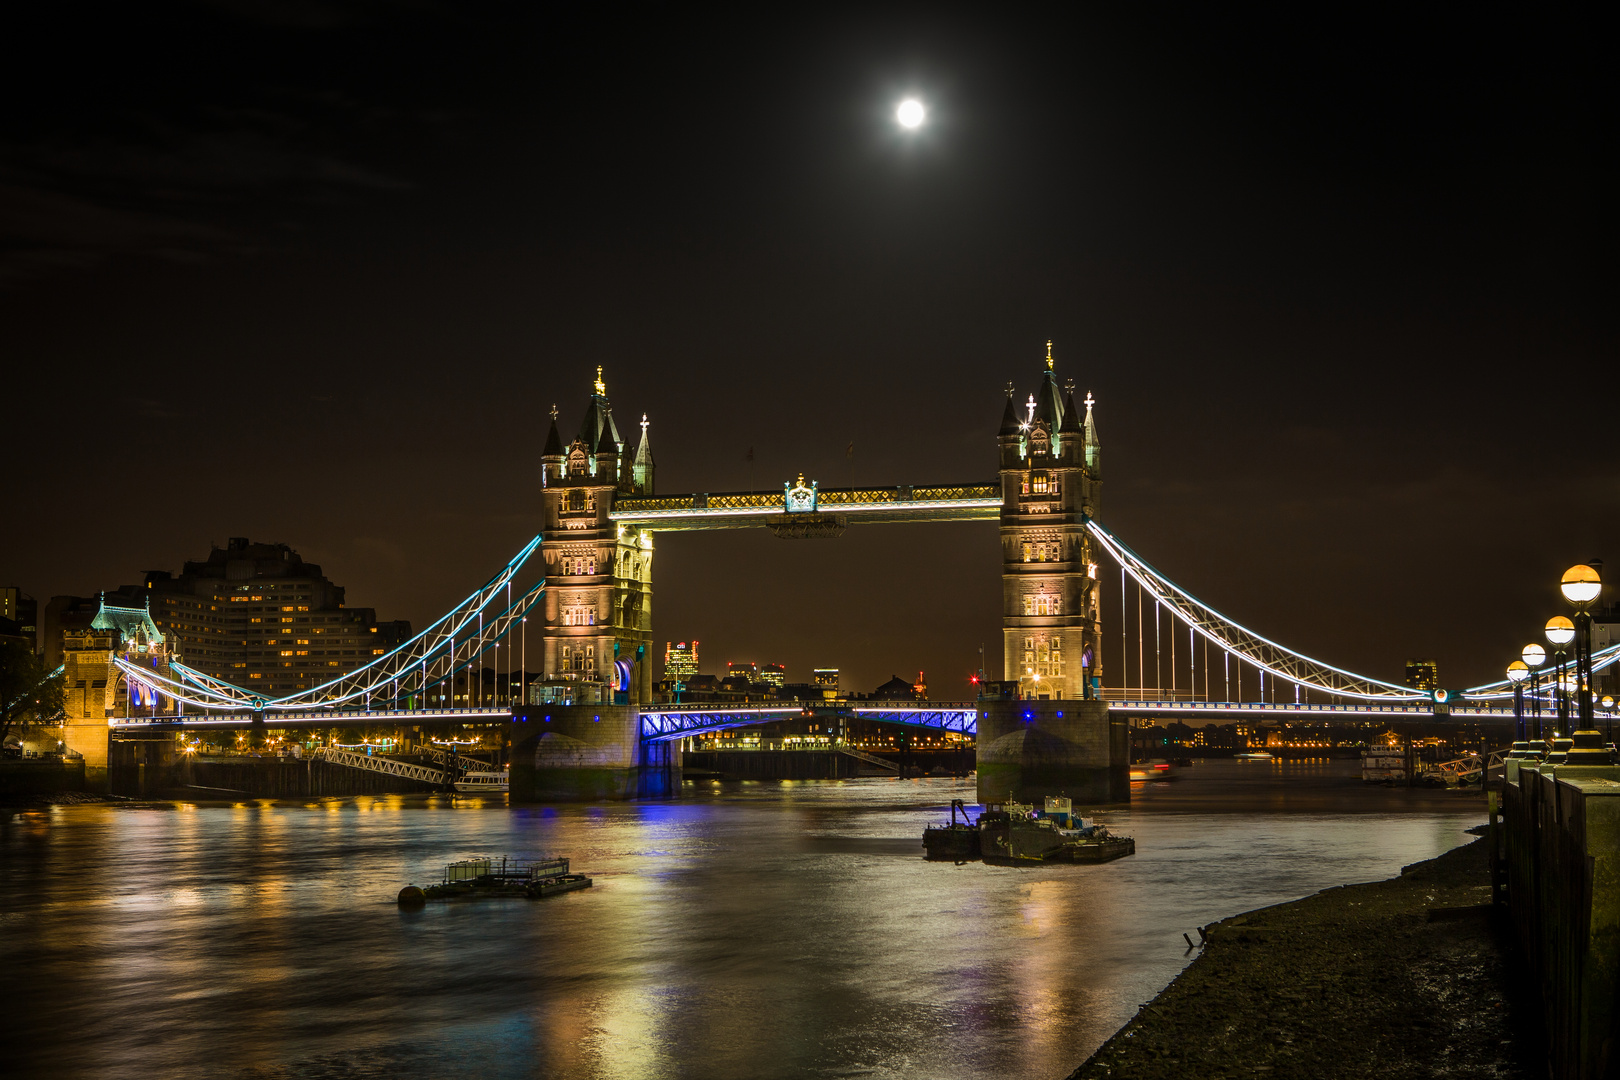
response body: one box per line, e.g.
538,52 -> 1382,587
996,342 -> 1103,698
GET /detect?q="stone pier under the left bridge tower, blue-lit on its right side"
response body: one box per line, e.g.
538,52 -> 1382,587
509,704 -> 680,803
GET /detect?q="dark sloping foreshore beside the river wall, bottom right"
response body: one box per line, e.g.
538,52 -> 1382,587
1069,840 -> 1545,1080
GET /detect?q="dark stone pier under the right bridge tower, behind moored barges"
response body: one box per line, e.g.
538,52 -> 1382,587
977,699 -> 1131,805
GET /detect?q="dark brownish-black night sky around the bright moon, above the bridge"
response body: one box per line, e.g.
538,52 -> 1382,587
0,0 -> 1620,698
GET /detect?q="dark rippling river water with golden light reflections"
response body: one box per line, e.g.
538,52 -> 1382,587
0,761 -> 1484,1080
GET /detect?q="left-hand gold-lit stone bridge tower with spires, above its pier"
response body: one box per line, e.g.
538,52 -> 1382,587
531,368 -> 653,704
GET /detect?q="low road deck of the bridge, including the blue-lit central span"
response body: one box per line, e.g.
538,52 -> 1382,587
107,699 -> 1548,742
